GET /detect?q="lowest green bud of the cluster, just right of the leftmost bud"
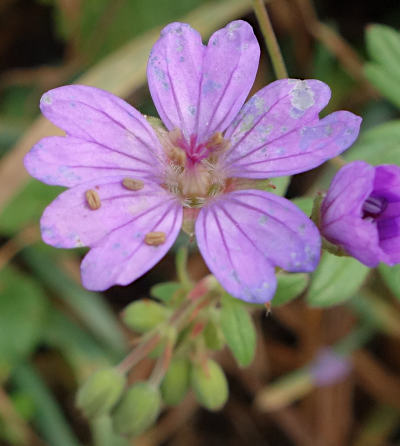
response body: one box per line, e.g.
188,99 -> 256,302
113,381 -> 161,436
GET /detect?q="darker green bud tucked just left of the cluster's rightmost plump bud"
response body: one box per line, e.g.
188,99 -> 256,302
161,358 -> 190,406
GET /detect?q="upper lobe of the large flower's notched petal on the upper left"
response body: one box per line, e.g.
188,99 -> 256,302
40,85 -> 164,175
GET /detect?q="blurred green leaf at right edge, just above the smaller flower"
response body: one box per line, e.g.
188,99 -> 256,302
344,120 -> 400,166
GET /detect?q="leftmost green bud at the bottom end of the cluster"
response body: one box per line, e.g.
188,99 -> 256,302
76,368 -> 126,418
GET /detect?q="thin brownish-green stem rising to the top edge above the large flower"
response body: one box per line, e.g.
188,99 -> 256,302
253,0 -> 288,79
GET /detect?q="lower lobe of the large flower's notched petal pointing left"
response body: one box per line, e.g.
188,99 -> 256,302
24,136 -> 159,187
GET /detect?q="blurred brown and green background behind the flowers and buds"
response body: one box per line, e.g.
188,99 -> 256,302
0,0 -> 400,446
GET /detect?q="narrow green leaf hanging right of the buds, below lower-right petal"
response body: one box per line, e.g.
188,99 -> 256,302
221,294 -> 256,367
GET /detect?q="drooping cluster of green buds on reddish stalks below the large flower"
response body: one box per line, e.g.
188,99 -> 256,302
76,276 -> 236,436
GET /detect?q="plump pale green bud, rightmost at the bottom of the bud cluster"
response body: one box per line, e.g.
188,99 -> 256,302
190,359 -> 229,410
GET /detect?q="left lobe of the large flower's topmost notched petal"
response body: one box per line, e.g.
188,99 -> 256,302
147,22 -> 204,141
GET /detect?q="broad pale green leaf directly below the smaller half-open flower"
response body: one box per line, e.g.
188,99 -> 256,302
307,252 -> 369,307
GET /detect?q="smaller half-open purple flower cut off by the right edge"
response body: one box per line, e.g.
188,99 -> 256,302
321,161 -> 400,267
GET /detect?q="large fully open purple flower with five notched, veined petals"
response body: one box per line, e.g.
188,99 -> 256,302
25,21 -> 360,302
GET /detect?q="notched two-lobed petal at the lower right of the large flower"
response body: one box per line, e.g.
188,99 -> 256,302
196,190 -> 320,302
